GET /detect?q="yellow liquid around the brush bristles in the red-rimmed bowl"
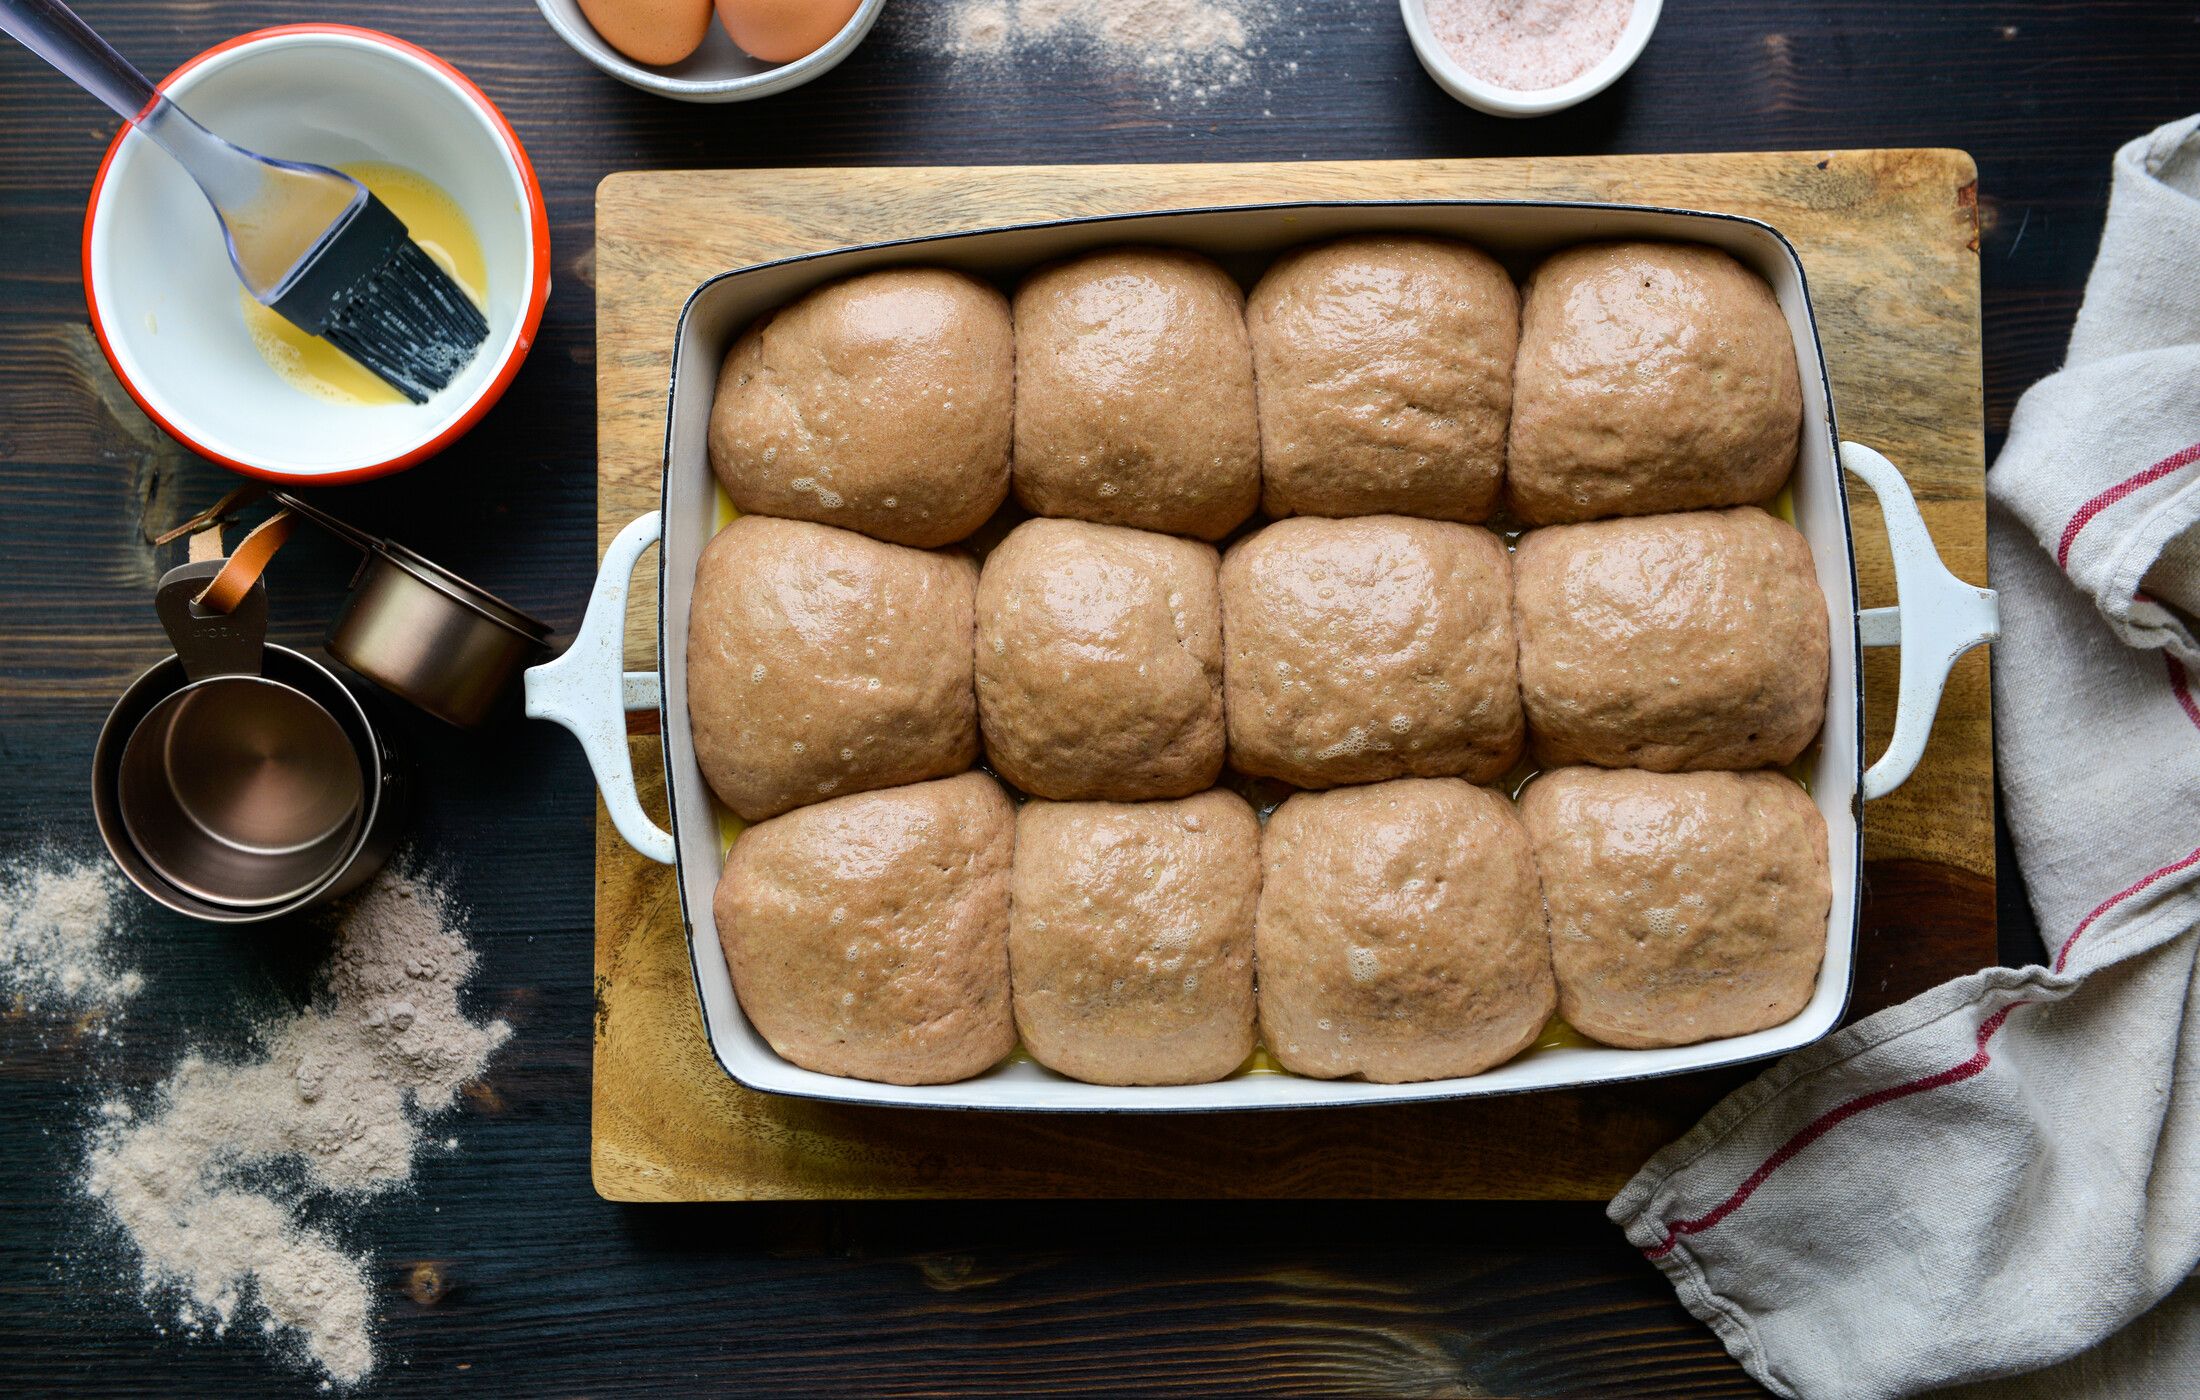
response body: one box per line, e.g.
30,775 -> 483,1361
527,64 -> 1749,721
238,161 -> 488,407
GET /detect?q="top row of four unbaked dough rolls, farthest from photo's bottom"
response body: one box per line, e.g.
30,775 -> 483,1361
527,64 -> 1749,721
711,233 -> 1802,546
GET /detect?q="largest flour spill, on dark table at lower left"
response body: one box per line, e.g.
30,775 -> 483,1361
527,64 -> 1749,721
81,872 -> 510,1385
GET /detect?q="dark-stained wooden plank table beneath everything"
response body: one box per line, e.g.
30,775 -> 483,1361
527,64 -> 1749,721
0,0 -> 2200,1396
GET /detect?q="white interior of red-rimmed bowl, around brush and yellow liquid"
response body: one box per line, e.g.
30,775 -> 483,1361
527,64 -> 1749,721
88,33 -> 535,478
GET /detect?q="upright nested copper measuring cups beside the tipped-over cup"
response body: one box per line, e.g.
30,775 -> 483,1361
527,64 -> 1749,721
92,559 -> 407,922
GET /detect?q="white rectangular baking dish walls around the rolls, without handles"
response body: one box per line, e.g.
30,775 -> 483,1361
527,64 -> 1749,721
658,203 -> 1863,1112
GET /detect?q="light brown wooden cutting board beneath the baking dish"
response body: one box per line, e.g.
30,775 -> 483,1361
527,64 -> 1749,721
592,150 -> 1995,1202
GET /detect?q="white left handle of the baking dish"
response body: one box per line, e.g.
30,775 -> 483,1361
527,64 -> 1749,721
528,511 -> 673,865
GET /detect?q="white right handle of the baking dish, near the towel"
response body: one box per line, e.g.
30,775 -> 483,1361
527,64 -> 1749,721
1841,442 -> 2002,801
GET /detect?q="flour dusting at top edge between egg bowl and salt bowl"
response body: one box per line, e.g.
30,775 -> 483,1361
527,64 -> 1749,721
935,0 -> 1298,101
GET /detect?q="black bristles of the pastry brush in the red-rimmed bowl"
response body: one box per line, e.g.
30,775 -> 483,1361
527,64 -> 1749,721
268,196 -> 488,403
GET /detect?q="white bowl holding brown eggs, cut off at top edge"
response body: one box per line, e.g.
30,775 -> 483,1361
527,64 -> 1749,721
535,0 -> 887,101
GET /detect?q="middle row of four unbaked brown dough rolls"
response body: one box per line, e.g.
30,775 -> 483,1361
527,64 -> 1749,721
686,506 -> 1828,821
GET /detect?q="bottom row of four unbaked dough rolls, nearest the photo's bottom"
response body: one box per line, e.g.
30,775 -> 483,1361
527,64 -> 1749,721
713,768 -> 1833,1085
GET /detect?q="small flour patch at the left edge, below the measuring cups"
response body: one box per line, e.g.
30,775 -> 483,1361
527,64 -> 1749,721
0,856 -> 145,1017
